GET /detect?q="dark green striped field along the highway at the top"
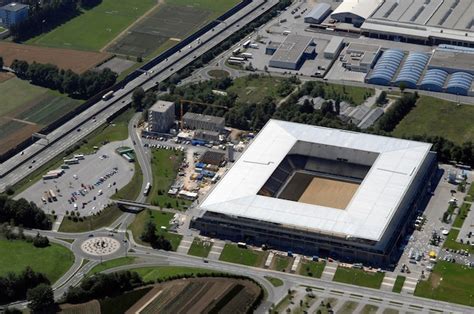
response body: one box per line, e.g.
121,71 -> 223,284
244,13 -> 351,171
107,0 -> 238,57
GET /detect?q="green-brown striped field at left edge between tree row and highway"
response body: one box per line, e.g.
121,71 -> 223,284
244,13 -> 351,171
0,77 -> 80,154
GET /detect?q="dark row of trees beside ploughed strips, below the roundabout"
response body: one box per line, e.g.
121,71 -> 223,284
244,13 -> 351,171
63,271 -> 143,303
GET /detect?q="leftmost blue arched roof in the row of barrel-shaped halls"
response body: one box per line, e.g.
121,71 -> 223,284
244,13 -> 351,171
367,49 -> 404,86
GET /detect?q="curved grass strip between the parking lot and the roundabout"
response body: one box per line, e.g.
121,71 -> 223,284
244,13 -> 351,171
59,206 -> 123,232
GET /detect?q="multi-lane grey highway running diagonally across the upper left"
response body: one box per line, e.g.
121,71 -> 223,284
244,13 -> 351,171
0,0 -> 278,192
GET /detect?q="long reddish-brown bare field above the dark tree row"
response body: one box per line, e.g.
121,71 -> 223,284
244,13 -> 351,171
0,42 -> 111,73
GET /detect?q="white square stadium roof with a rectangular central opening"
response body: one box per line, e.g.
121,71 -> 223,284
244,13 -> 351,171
200,120 -> 431,241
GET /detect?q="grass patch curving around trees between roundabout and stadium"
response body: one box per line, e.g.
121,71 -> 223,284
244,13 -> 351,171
129,209 -> 183,251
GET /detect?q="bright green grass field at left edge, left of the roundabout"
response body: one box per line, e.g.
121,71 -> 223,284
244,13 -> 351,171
0,239 -> 74,283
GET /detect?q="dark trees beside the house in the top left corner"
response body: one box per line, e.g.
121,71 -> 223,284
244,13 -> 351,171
10,0 -> 102,42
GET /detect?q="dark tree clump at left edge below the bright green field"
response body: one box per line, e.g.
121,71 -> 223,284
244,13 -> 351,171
0,266 -> 50,304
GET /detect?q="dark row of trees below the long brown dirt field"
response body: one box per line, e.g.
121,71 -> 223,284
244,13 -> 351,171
10,59 -> 117,99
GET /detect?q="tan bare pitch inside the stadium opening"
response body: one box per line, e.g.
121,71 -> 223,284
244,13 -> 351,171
298,177 -> 359,209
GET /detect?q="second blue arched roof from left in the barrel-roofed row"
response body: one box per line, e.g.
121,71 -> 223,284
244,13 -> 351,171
394,52 -> 429,89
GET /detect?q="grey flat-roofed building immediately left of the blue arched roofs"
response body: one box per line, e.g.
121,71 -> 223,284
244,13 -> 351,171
341,43 -> 382,73
